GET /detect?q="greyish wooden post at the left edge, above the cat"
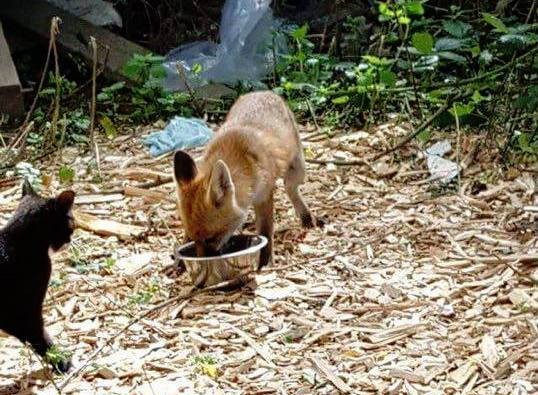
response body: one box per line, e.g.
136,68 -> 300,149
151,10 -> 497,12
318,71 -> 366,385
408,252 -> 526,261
0,21 -> 24,118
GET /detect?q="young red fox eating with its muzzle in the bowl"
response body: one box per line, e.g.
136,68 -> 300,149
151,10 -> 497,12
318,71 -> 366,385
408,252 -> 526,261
174,91 -> 315,268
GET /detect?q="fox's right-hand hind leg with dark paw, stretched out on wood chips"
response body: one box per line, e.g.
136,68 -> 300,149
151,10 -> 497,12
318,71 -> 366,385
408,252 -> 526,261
284,147 -> 316,228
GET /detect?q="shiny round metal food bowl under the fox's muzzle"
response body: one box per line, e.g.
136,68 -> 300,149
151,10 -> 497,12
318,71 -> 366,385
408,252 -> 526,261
174,235 -> 267,288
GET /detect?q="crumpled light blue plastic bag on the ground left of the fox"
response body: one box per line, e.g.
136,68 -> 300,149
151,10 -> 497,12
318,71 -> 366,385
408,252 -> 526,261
143,117 -> 213,157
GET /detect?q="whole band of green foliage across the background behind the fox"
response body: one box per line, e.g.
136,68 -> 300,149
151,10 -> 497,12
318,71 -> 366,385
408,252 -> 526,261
0,0 -> 538,164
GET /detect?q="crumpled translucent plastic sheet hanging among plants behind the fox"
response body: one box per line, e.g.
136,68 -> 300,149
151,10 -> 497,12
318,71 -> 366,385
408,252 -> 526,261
163,0 -> 287,91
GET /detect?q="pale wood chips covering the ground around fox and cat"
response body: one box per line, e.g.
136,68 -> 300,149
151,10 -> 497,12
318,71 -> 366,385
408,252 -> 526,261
0,125 -> 538,395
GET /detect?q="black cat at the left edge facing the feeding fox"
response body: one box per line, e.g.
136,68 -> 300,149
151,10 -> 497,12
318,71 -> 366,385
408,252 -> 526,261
0,181 -> 75,372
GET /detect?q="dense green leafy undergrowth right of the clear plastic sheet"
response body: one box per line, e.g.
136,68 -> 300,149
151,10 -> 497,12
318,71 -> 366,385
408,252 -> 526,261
275,0 -> 538,153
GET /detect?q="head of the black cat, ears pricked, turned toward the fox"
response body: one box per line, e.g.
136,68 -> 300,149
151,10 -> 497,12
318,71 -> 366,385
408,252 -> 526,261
15,181 -> 75,251
